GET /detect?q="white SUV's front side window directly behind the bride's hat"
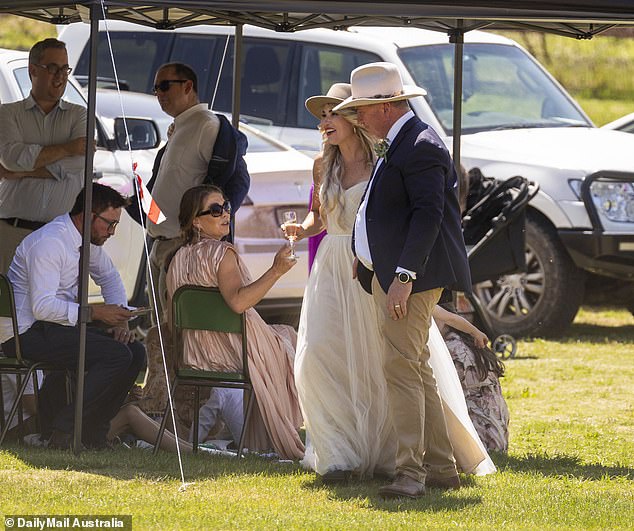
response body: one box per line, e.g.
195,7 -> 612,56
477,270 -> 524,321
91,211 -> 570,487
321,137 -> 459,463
298,44 -> 381,127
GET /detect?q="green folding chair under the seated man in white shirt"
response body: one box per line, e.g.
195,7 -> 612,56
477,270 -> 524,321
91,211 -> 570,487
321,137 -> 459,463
0,273 -> 68,446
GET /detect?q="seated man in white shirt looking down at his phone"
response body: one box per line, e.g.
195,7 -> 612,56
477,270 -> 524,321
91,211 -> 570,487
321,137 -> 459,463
0,183 -> 145,449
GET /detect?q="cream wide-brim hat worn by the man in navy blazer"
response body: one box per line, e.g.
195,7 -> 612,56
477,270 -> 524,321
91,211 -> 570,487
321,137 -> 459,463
333,63 -> 427,111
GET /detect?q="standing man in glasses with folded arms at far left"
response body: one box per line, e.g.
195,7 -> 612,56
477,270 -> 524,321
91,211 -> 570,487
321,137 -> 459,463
0,39 -> 86,273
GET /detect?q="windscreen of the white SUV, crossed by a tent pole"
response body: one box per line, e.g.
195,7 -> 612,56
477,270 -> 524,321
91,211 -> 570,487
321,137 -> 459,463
398,44 -> 590,134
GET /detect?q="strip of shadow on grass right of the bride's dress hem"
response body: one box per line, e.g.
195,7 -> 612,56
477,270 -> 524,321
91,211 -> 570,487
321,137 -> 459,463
494,453 -> 634,481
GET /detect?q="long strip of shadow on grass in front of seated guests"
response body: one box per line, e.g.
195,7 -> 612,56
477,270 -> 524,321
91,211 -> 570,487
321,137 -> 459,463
2,445 -> 300,482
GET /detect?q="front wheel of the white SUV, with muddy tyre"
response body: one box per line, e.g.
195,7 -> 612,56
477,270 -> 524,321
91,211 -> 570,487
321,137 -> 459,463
474,219 -> 584,337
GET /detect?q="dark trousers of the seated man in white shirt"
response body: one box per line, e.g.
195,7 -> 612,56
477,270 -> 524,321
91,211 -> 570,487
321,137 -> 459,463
2,321 -> 145,445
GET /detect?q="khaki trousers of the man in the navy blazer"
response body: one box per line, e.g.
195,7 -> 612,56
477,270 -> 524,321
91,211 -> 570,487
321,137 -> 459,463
372,275 -> 457,482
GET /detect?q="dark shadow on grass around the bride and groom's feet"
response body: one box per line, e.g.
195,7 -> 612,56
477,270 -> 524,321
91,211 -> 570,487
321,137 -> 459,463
302,476 -> 482,512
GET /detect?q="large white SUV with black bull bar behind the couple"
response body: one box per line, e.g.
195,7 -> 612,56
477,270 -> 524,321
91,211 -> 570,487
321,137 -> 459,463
60,21 -> 634,335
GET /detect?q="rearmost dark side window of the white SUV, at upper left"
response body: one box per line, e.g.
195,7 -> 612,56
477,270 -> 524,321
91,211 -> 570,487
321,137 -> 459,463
75,31 -> 172,94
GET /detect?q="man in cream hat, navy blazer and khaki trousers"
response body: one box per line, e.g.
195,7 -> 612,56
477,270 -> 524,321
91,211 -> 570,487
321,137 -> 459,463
333,63 -> 471,498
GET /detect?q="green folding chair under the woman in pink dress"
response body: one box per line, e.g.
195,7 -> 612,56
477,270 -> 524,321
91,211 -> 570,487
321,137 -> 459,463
154,285 -> 255,457
